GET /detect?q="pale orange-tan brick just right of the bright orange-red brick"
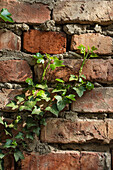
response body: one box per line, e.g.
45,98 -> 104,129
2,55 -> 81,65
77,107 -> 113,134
71,33 -> 112,54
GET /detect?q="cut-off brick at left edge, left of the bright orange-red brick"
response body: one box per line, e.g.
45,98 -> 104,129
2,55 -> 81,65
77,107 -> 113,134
0,29 -> 21,50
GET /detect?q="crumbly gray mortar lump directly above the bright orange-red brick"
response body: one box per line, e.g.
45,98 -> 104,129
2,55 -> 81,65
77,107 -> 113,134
33,20 -> 62,32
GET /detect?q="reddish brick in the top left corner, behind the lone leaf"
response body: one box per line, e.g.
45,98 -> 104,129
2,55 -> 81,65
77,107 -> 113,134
0,0 -> 50,23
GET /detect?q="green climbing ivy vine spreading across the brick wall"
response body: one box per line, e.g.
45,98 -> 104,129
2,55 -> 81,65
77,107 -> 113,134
0,9 -> 97,169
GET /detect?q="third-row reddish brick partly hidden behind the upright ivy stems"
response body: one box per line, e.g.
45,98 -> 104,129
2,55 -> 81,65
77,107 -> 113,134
34,59 -> 113,84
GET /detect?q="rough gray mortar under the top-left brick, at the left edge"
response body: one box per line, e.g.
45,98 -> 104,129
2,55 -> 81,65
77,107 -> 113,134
0,23 -> 30,36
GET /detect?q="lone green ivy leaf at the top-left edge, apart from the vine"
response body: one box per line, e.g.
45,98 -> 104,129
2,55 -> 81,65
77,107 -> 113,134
0,8 -> 14,22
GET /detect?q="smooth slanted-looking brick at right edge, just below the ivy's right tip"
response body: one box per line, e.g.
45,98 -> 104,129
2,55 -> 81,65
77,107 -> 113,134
71,87 -> 113,113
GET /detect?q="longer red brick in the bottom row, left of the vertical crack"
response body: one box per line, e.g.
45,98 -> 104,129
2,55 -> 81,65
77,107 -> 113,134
21,151 -> 80,170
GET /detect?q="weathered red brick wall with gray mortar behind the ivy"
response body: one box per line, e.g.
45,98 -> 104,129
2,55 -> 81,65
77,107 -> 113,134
0,0 -> 113,170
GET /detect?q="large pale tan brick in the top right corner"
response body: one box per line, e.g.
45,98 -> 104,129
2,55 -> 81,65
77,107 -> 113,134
53,0 -> 113,24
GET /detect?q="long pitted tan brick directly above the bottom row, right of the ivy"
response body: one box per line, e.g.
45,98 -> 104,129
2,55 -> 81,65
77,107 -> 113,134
41,119 -> 109,143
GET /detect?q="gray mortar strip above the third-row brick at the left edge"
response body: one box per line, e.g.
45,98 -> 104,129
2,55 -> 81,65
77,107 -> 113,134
0,50 -> 36,66
